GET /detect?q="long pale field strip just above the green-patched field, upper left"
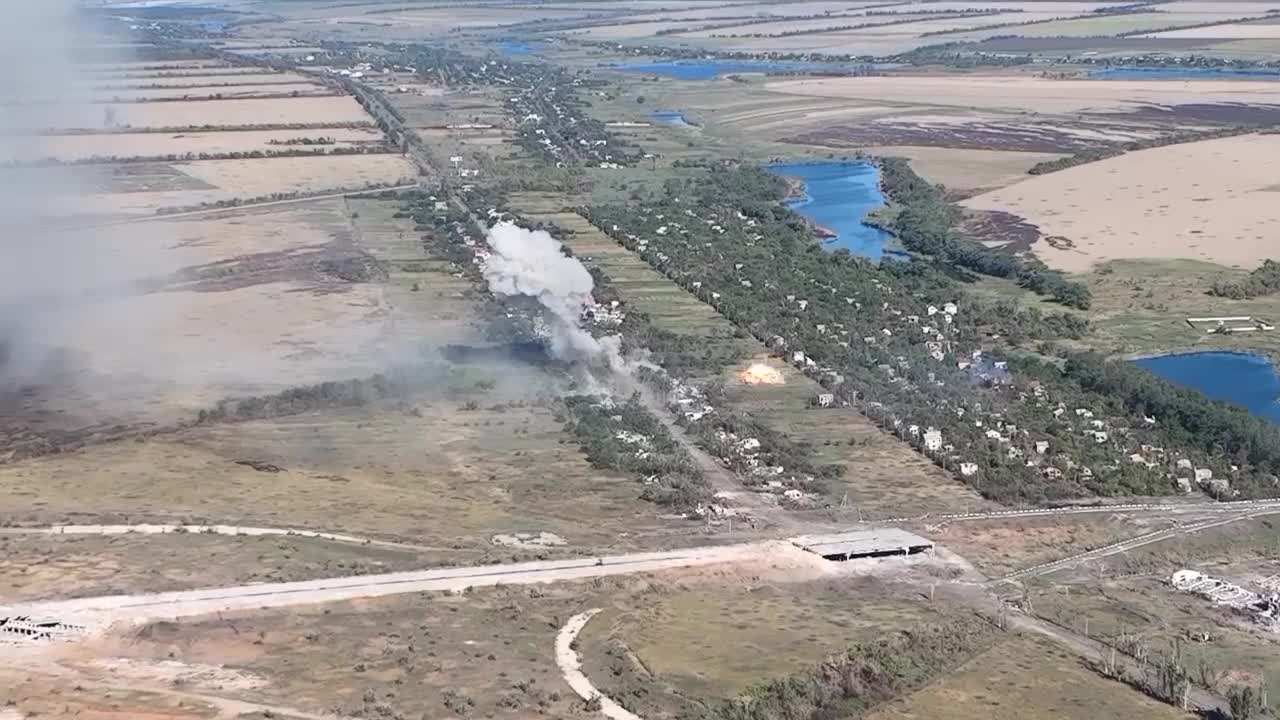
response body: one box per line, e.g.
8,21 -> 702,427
0,128 -> 384,163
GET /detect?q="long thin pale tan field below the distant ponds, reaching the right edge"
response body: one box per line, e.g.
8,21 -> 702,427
768,74 -> 1280,113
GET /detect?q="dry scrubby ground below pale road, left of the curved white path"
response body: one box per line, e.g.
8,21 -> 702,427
73,584 -> 611,720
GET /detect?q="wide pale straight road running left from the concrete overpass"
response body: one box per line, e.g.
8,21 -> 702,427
0,542 -> 773,632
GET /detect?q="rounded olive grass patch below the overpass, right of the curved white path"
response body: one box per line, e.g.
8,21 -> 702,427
579,575 -> 934,717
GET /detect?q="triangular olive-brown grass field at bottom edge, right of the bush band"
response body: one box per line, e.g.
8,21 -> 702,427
869,637 -> 1194,720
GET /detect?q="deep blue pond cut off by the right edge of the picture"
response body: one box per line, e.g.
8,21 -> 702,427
1134,352 -> 1280,423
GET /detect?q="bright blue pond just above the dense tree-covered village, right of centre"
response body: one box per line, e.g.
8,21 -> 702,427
769,160 -> 893,260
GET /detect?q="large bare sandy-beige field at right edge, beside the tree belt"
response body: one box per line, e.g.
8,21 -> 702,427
964,135 -> 1280,270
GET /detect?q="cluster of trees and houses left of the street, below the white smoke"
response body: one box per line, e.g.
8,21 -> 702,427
562,395 -> 712,511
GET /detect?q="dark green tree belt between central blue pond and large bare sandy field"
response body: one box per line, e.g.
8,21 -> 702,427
881,158 -> 1092,310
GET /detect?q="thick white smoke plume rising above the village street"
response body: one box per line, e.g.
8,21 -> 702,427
484,222 -> 627,373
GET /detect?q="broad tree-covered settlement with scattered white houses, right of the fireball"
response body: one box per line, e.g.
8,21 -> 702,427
584,165 -> 1280,502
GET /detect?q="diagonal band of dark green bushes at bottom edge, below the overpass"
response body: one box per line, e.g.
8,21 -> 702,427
690,615 -> 1000,720
